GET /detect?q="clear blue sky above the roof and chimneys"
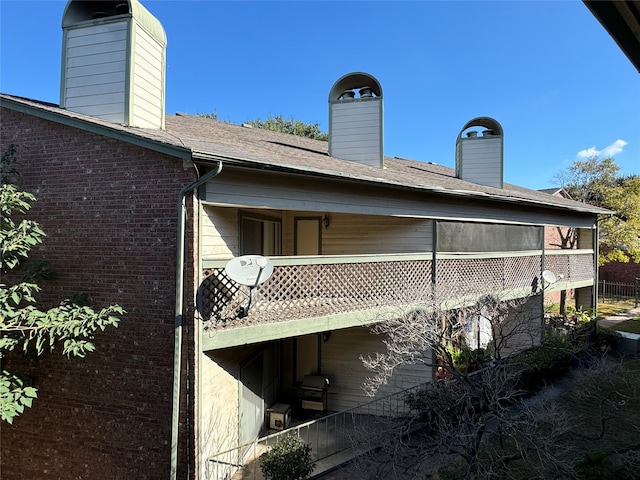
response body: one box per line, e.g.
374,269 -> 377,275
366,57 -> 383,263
0,0 -> 640,189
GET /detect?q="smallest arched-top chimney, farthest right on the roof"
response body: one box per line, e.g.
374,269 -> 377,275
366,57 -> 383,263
456,117 -> 503,188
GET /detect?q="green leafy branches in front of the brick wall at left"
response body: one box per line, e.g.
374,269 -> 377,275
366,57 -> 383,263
0,146 -> 125,423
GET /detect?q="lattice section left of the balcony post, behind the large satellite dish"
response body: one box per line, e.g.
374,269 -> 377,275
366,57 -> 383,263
198,260 -> 431,326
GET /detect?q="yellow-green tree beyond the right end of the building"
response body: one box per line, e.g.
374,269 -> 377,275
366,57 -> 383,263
556,157 -> 640,265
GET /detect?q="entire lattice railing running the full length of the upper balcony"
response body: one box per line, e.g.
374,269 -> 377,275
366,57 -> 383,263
198,250 -> 594,328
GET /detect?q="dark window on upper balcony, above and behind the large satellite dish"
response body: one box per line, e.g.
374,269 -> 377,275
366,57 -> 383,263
240,216 -> 282,256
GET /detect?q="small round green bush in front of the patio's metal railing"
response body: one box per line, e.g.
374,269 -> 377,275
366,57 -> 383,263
260,434 -> 315,480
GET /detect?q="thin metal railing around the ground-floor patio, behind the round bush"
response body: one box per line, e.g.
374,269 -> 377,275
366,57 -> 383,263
206,383 -> 427,480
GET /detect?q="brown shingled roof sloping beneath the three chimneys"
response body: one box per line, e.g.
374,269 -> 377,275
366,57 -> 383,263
0,94 -> 612,214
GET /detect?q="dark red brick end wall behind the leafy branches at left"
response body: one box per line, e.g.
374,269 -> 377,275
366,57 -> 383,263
0,109 -> 194,480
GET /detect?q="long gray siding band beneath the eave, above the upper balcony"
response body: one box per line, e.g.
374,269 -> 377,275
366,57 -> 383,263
205,168 -> 593,228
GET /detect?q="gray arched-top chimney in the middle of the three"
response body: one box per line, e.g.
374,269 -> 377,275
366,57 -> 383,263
329,72 -> 384,168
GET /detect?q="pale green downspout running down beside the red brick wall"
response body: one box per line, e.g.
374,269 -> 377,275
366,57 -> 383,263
170,162 -> 222,480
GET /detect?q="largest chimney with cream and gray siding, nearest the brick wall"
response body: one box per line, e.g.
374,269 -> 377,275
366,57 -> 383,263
60,0 -> 167,129
